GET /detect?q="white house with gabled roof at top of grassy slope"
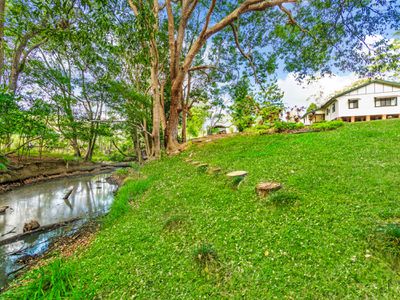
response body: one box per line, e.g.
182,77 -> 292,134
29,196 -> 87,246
302,79 -> 400,124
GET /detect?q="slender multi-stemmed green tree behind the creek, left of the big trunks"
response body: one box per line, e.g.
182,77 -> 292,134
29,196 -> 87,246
24,1 -> 120,160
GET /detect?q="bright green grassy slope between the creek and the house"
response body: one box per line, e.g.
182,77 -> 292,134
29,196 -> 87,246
3,120 -> 400,299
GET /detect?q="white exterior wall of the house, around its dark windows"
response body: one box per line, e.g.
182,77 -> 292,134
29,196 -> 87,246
324,83 -> 400,120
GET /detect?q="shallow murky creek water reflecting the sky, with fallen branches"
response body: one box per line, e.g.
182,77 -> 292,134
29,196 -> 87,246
0,174 -> 116,287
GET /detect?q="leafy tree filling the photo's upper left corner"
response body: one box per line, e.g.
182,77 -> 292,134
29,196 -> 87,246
0,0 -> 88,93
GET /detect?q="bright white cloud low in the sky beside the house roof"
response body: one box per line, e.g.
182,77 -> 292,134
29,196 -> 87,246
278,73 -> 358,107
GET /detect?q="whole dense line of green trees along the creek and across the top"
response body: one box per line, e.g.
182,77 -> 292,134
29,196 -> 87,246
0,0 -> 400,160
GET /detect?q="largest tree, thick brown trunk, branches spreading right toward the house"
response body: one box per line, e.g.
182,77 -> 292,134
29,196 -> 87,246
130,0 -> 399,152
